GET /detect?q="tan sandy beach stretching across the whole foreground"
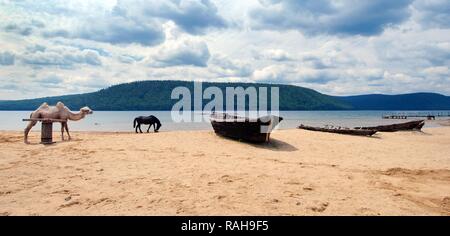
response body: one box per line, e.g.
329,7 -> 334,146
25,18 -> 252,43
0,127 -> 450,215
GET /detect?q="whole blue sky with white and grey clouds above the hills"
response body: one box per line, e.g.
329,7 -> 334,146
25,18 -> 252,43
0,0 -> 450,99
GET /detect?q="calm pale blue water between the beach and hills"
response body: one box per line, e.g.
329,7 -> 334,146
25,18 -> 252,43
0,111 -> 450,131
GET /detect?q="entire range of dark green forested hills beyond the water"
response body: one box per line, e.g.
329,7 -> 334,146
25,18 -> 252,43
0,81 -> 450,111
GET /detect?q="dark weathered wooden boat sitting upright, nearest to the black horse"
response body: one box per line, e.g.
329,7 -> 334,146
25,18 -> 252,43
210,113 -> 283,143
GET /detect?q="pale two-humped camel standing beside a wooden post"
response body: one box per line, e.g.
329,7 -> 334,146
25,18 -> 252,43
24,102 -> 93,143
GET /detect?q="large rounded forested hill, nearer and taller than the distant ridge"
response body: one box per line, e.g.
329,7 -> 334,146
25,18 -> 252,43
0,81 -> 352,111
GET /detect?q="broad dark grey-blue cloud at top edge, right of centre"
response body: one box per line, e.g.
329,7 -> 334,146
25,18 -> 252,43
250,0 -> 412,35
